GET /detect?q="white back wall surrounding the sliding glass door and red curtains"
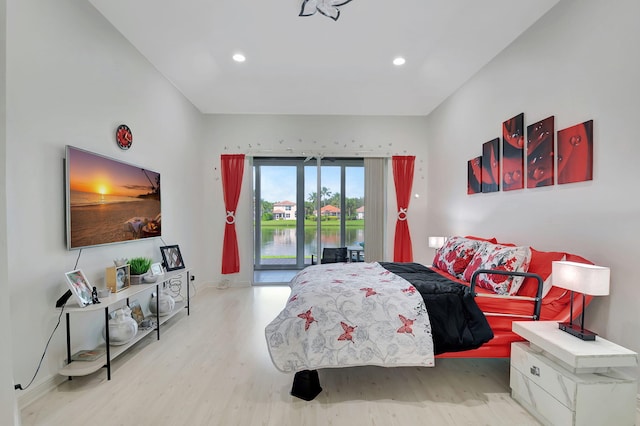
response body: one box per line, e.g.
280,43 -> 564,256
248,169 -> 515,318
201,115 -> 426,285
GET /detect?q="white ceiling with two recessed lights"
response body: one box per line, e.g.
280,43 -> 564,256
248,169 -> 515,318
89,0 -> 559,115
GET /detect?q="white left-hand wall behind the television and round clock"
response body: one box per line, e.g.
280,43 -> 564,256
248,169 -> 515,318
5,0 -> 204,408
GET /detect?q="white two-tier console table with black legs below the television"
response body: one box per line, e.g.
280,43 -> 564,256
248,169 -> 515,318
58,269 -> 190,380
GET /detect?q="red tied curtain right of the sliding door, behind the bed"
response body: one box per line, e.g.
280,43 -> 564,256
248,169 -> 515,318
392,156 -> 416,262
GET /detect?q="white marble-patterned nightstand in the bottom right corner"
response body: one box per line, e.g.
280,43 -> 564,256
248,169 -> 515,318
510,321 -> 638,426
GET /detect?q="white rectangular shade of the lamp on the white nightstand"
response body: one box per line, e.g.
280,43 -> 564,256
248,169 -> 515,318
551,261 -> 610,296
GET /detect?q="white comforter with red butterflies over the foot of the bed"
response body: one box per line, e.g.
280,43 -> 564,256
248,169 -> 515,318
265,262 -> 434,372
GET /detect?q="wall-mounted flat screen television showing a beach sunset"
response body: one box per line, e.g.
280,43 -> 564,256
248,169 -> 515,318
65,145 -> 162,250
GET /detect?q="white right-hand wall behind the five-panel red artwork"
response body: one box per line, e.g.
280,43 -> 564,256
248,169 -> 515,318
427,0 -> 640,378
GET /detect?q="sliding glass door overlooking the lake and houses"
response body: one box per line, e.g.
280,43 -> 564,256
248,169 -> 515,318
253,158 -> 364,270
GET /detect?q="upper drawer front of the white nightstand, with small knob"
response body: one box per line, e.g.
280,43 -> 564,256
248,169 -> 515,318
511,343 -> 576,410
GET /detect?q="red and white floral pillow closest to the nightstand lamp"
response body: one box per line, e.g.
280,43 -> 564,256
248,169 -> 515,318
463,243 -> 531,295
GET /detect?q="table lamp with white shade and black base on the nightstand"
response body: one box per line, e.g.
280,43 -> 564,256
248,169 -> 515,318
551,261 -> 610,340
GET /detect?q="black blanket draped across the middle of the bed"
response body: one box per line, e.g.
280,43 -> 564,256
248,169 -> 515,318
380,262 -> 493,355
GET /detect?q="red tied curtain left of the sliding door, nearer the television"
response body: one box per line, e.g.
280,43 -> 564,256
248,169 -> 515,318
220,154 -> 244,274
